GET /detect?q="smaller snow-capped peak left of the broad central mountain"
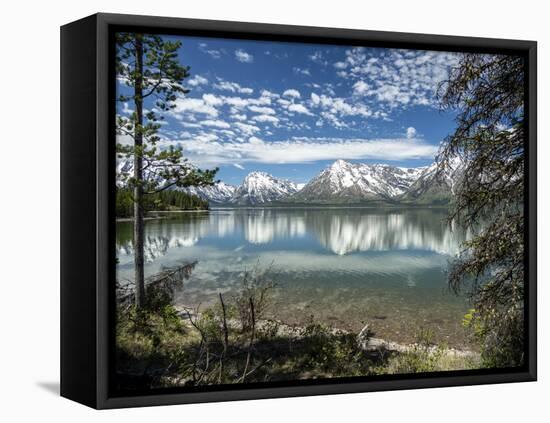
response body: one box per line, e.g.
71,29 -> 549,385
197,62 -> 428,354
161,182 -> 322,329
230,172 -> 298,205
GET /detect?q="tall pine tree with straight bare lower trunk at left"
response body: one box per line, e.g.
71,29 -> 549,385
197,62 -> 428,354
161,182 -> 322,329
116,33 -> 217,309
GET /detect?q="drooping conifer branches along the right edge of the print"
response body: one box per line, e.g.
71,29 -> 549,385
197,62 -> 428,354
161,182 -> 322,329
439,54 -> 525,367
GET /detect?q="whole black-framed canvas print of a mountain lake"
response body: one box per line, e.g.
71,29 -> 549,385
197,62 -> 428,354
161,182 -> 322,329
61,14 -> 536,408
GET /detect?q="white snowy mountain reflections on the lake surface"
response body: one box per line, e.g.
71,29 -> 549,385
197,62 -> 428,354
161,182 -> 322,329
117,209 -> 466,262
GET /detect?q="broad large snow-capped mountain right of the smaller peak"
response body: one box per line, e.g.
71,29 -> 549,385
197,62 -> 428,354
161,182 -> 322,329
293,160 -> 427,201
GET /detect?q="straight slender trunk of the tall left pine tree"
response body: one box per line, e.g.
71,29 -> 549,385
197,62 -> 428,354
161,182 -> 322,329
134,34 -> 145,309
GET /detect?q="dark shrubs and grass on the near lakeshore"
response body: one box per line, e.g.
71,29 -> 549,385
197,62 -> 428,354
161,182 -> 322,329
116,263 -> 482,391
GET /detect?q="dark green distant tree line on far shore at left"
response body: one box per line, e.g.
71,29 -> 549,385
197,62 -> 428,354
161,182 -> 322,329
116,188 -> 208,217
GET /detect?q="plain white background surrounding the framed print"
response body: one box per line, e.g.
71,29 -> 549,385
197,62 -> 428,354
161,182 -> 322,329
0,0 -> 550,423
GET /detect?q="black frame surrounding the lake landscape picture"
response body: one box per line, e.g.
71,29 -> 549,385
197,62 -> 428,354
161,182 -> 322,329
61,13 -> 537,409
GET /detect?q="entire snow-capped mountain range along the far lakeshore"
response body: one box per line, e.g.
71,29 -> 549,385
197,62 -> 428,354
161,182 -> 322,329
117,160 -> 462,206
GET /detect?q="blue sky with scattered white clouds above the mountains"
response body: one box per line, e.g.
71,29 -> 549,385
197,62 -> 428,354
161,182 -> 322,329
118,37 -> 466,184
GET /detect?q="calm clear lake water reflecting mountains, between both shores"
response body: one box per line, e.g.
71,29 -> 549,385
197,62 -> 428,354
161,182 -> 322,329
116,208 -> 469,347
